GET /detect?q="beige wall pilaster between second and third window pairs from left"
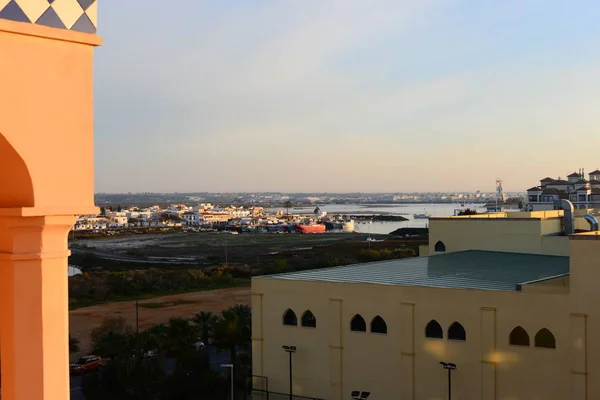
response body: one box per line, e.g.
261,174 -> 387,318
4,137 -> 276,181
400,303 -> 415,400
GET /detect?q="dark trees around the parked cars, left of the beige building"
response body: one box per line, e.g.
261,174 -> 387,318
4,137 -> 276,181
83,305 -> 252,400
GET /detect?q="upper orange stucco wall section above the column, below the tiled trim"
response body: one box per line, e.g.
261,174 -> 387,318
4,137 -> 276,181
0,20 -> 99,209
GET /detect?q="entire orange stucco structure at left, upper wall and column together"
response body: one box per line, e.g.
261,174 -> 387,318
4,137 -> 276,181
0,16 -> 100,400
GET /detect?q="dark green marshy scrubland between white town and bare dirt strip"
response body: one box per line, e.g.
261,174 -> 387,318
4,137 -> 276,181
69,233 -> 426,309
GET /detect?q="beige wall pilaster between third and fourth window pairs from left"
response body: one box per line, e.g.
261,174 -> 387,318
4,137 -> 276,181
481,307 -> 496,400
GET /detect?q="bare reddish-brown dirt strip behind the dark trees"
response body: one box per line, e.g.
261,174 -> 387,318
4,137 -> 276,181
69,287 -> 250,352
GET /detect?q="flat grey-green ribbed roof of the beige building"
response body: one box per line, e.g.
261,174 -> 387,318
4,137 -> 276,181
261,250 -> 569,291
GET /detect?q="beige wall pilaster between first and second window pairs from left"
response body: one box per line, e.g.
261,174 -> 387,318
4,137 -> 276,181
329,298 -> 345,400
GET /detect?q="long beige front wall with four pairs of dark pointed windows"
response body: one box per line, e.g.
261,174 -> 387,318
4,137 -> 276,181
252,278 -> 571,400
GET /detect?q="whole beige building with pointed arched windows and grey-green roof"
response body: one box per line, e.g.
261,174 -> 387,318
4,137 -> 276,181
252,205 -> 600,400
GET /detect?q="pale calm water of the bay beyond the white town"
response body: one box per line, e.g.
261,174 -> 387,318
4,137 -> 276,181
281,203 -> 485,234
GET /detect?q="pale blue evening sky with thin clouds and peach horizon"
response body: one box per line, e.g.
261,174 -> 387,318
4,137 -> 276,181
94,0 -> 600,192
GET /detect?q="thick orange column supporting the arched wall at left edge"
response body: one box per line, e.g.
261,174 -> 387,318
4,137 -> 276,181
0,216 -> 75,400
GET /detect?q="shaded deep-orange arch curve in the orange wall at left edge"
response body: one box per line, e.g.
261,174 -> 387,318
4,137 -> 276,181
0,133 -> 34,208
